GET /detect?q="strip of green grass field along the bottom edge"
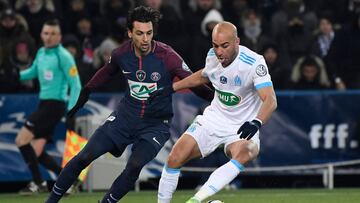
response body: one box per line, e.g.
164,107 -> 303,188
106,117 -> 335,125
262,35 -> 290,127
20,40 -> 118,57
0,188 -> 360,203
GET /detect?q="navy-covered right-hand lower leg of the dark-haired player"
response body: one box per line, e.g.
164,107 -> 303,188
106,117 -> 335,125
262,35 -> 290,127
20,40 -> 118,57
101,140 -> 158,203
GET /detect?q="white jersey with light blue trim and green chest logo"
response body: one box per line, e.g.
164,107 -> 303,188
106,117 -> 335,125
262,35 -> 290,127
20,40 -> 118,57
202,46 -> 272,134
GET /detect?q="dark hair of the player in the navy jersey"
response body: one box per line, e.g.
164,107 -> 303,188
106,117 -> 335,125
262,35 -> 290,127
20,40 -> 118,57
127,6 -> 160,30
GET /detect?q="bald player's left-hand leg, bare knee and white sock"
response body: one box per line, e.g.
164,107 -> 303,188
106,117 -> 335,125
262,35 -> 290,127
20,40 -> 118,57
158,134 -> 201,203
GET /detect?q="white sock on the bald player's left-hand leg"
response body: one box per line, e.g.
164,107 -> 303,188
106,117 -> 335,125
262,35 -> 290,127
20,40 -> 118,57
158,165 -> 180,203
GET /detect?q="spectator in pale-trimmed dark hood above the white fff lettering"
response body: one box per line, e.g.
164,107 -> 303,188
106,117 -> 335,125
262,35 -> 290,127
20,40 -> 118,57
291,56 -> 330,90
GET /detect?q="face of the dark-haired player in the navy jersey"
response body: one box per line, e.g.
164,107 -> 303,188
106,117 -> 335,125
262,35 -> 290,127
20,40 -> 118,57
128,21 -> 154,55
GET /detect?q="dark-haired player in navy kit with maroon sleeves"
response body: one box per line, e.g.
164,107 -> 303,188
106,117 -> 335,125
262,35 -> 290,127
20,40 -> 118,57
46,6 -> 213,203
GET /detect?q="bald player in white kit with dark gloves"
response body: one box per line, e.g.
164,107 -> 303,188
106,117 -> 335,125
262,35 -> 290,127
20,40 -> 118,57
150,22 -> 277,203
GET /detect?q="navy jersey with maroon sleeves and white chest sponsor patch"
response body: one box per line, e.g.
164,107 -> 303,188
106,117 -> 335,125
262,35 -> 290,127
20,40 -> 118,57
86,41 -> 211,119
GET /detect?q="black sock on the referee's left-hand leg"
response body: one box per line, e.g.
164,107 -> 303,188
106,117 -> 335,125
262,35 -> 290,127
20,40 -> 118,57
19,144 -> 43,185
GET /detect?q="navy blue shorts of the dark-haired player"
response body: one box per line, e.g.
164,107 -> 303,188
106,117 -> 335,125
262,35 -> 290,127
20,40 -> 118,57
94,111 -> 170,157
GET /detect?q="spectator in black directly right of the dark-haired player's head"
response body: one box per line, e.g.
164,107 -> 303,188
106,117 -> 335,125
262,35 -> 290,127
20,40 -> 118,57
144,0 -> 185,55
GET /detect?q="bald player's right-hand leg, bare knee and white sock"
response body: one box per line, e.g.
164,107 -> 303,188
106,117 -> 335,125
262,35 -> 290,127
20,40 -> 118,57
188,140 -> 259,203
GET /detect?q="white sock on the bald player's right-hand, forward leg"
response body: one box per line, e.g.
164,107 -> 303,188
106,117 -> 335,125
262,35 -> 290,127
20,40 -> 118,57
194,159 -> 244,201
